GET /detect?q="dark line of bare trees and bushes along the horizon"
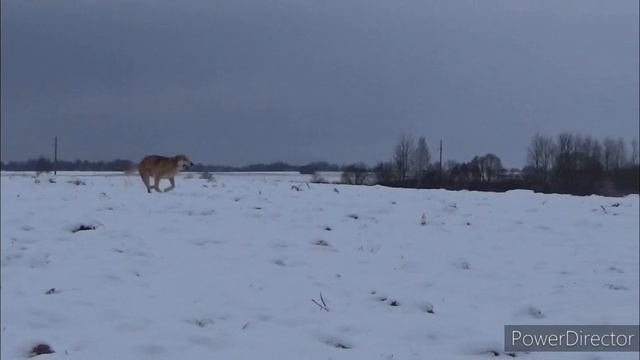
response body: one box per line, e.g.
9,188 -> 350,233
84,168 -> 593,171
0,133 -> 640,196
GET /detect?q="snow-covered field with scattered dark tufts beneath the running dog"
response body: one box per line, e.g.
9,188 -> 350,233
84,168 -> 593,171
1,174 -> 639,360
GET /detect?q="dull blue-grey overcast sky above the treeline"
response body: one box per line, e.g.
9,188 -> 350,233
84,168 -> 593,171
1,0 -> 639,167
